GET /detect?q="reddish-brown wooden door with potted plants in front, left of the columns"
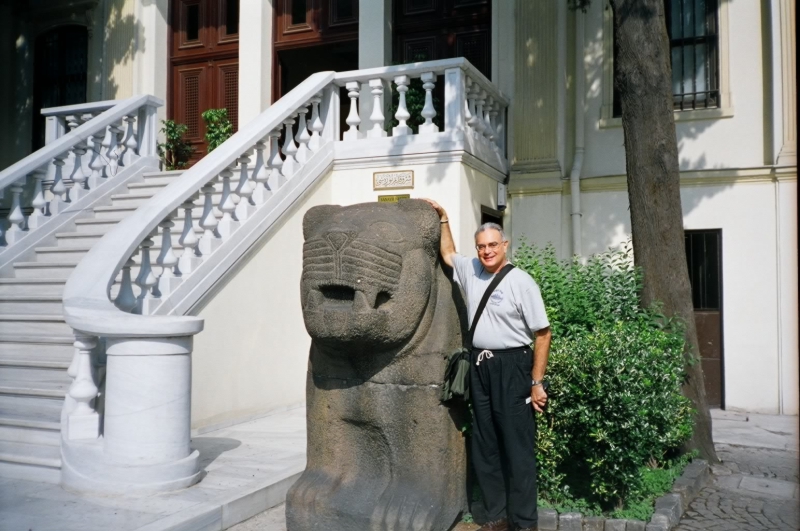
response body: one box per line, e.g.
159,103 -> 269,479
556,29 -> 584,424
167,0 -> 239,162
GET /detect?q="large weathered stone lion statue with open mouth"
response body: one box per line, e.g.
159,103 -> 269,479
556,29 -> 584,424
286,200 -> 466,531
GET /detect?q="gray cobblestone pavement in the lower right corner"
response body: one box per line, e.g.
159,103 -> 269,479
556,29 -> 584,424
675,444 -> 800,531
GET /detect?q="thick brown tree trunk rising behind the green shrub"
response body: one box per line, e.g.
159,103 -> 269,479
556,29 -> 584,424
611,0 -> 718,463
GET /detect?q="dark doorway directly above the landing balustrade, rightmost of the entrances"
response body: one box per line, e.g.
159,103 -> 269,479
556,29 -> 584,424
393,0 -> 492,78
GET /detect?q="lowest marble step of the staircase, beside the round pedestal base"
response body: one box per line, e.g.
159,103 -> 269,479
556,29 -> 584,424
0,441 -> 61,483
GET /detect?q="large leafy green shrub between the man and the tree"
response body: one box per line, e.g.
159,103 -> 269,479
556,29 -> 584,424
514,244 -> 692,514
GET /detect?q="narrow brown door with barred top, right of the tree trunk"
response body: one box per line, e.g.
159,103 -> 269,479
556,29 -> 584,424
685,230 -> 725,408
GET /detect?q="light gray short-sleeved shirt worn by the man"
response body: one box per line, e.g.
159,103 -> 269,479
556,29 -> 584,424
453,254 -> 550,349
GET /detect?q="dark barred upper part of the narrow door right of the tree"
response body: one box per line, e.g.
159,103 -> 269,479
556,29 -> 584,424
684,230 -> 722,310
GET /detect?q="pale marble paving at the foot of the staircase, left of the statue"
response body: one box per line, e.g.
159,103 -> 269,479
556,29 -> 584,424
0,408 -> 306,531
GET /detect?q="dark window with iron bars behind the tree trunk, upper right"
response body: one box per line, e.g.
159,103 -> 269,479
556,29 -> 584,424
614,0 -> 720,116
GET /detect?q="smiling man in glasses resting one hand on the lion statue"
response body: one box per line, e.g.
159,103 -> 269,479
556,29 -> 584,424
426,199 -> 550,531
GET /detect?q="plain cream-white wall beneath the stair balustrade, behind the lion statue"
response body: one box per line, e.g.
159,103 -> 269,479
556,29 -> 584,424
192,162 -> 497,432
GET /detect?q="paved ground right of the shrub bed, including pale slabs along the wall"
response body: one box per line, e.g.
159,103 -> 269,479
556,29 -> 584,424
676,412 -> 800,531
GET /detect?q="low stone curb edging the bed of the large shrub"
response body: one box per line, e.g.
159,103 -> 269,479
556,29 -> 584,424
539,459 -> 710,531
